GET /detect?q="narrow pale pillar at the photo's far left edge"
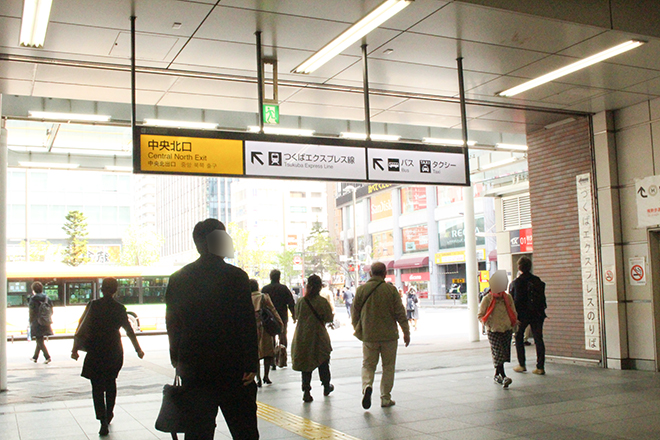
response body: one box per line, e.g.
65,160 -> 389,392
0,95 -> 7,391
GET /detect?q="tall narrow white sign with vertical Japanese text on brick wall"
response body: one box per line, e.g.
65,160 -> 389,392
576,173 -> 600,350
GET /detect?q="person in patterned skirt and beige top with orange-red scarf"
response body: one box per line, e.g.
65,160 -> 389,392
477,270 -> 518,389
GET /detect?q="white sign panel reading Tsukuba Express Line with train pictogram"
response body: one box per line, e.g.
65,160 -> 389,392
244,141 -> 367,180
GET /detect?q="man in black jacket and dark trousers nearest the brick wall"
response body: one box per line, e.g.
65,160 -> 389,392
509,257 -> 546,374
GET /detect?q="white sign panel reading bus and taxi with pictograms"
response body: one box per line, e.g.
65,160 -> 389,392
367,148 -> 467,185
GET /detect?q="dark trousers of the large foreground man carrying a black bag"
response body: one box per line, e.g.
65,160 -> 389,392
184,381 -> 259,440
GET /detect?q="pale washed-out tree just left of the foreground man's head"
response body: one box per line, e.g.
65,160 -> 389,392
119,226 -> 165,266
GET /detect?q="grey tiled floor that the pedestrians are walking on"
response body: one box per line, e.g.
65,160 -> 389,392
0,308 -> 660,440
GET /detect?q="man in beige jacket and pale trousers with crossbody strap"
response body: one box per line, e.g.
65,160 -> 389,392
351,263 -> 410,409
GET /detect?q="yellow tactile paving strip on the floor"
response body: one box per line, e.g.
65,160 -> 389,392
257,402 -> 360,440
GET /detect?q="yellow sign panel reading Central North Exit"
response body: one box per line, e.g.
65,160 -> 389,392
140,134 -> 244,176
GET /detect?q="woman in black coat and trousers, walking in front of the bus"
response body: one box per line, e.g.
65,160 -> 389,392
71,278 -> 144,435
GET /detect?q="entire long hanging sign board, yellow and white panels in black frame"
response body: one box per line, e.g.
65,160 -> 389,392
133,126 -> 470,185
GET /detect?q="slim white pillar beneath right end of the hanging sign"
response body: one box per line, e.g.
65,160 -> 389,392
463,185 -> 480,342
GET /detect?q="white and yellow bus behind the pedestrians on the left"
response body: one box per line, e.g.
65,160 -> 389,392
7,263 -> 178,338
